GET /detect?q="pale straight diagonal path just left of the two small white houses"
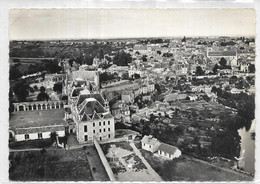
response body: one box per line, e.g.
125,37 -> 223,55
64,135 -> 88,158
130,142 -> 163,181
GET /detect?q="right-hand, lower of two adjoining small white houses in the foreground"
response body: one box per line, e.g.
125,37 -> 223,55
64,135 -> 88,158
158,143 -> 181,159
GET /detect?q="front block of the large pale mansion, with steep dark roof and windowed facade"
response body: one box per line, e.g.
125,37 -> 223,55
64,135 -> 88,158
71,93 -> 115,143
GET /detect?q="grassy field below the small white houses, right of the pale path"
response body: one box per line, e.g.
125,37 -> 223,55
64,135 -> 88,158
142,150 -> 253,181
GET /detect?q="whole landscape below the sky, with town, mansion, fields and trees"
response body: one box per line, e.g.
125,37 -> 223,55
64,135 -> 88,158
9,8 -> 256,182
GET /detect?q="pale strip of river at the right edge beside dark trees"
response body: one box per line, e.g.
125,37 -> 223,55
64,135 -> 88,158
238,120 -> 255,174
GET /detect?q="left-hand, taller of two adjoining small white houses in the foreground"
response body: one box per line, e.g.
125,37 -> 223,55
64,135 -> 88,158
141,135 -> 161,153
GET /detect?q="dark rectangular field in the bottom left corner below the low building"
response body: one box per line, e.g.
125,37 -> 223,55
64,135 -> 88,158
9,149 -> 93,181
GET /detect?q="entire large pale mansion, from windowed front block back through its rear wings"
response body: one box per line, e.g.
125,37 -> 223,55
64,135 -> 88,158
67,70 -> 115,143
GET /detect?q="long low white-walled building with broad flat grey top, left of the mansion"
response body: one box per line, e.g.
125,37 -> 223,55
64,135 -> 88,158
9,109 -> 67,141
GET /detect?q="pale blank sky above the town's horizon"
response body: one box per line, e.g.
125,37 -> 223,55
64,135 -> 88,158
9,8 -> 256,40
